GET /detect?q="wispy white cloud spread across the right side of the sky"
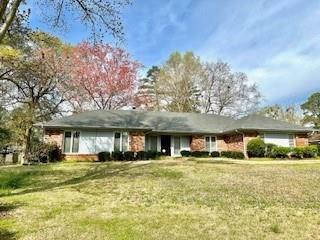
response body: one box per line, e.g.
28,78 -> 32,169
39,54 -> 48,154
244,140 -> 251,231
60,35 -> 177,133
199,0 -> 320,104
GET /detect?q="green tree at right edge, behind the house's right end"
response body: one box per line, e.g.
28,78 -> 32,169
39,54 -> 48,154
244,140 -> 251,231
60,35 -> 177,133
301,92 -> 320,128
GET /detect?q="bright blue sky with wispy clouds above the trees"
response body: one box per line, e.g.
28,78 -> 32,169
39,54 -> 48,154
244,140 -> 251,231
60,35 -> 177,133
31,0 -> 320,105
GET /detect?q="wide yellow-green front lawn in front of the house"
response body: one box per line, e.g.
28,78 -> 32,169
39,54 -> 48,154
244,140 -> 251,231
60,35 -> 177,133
0,160 -> 320,240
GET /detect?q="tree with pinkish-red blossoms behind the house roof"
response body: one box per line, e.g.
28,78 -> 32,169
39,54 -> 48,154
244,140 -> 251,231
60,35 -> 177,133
63,42 -> 140,112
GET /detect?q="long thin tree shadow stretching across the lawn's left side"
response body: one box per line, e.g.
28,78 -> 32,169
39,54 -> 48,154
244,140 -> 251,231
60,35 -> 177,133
0,162 -> 149,198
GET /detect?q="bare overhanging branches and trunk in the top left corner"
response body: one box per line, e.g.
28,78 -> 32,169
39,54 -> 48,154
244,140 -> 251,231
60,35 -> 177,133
0,0 -> 131,43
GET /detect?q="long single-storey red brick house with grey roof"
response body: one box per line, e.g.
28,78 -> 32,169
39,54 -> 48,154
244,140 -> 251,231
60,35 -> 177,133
37,110 -> 312,160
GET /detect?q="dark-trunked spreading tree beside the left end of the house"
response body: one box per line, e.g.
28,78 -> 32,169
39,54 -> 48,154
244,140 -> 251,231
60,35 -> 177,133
0,46 -> 65,158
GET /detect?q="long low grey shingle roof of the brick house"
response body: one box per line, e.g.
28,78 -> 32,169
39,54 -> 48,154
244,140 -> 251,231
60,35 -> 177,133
36,110 -> 312,134
